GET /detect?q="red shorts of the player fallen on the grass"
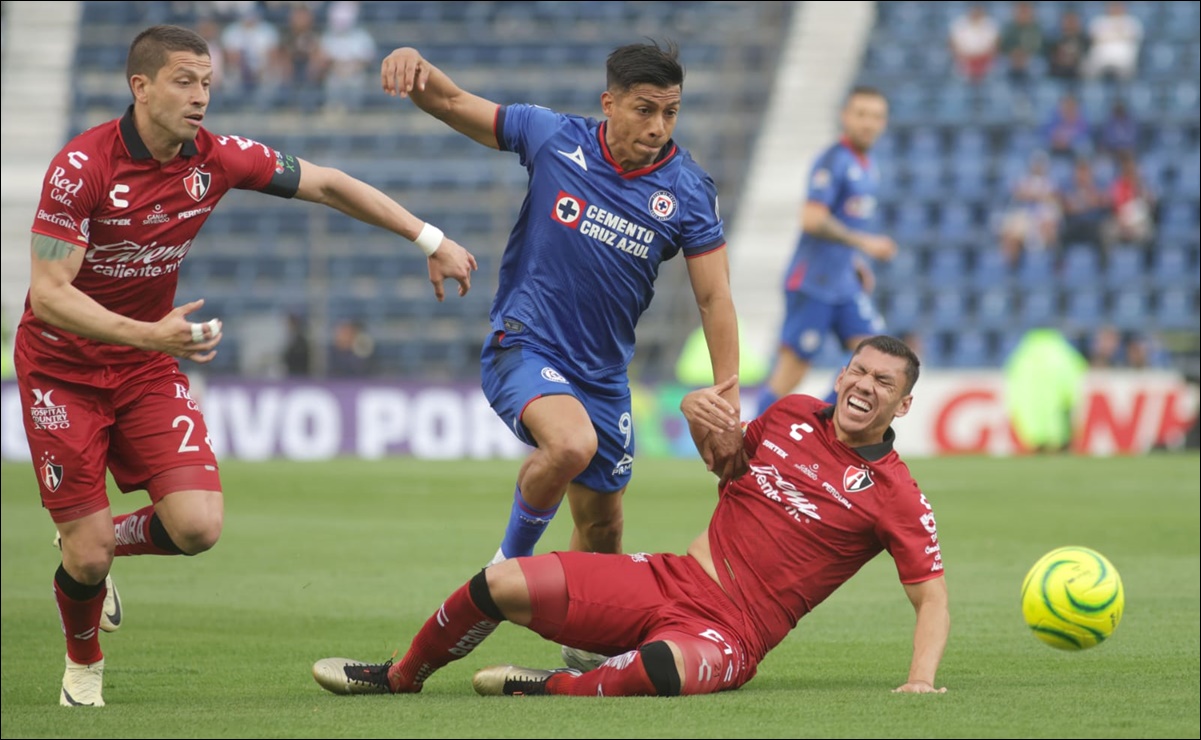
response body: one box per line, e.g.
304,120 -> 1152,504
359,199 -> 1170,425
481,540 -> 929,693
518,553 -> 763,694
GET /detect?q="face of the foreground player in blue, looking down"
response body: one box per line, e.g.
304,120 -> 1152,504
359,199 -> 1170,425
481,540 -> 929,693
601,84 -> 680,172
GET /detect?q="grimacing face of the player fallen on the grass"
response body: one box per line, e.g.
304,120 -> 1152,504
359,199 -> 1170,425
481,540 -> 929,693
833,347 -> 913,446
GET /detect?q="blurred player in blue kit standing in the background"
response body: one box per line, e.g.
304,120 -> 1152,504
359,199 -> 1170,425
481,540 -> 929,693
759,86 -> 897,412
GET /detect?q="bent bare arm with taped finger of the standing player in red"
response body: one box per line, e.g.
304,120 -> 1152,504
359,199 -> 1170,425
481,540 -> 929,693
29,234 -> 221,363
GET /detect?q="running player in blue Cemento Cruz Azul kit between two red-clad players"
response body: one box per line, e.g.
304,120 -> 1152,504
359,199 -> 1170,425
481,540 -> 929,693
381,37 -> 741,663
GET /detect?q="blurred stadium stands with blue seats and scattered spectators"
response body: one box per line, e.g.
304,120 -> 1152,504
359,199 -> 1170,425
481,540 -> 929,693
5,1 -> 1201,381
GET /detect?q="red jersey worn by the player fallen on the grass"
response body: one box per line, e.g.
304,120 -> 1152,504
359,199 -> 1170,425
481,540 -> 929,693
709,395 -> 943,652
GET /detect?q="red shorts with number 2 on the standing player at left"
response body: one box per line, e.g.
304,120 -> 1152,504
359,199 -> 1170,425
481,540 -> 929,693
16,333 -> 221,521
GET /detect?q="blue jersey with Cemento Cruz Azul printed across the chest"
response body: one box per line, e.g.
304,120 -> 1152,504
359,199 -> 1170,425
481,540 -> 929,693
490,105 -> 725,377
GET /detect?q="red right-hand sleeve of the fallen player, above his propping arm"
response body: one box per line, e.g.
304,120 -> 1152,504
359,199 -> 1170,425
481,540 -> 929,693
877,478 -> 943,584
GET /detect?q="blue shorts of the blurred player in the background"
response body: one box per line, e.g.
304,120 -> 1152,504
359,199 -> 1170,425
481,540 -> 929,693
779,291 -> 884,360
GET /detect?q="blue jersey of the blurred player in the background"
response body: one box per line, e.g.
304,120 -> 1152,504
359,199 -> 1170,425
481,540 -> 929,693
784,142 -> 880,303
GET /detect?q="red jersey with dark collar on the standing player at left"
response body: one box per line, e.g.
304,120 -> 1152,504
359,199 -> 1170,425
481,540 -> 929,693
20,106 -> 300,366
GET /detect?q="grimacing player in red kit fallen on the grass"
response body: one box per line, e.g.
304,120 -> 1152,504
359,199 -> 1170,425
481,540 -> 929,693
313,335 -> 950,697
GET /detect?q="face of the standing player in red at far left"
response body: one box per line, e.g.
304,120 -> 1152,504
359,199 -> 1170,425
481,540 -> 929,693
135,52 -> 213,144
